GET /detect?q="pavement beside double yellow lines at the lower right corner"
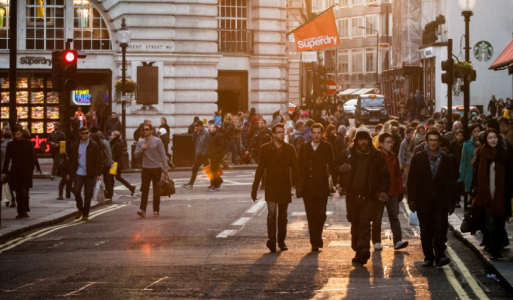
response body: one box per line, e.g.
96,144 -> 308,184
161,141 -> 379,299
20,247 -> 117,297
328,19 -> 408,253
449,208 -> 513,290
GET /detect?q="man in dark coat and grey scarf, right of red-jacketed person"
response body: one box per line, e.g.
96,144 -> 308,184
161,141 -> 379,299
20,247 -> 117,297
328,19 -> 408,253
407,130 -> 458,267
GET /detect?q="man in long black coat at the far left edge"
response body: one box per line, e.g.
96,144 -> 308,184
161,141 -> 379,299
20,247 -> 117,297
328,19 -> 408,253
1,125 -> 36,219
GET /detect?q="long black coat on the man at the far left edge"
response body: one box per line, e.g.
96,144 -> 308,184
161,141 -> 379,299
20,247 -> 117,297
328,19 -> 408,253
2,139 -> 35,190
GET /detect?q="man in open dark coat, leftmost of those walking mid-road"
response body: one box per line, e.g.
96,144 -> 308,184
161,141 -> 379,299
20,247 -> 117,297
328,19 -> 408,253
251,123 -> 301,252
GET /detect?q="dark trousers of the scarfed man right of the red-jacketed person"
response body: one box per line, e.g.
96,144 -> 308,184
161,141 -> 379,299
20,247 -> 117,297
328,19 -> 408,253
417,208 -> 449,261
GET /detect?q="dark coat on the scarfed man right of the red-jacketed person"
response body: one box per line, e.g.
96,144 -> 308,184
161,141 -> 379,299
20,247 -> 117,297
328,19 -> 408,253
407,151 -> 458,213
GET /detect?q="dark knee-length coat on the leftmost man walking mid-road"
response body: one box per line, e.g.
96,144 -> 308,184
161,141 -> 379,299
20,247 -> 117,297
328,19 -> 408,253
253,141 -> 301,204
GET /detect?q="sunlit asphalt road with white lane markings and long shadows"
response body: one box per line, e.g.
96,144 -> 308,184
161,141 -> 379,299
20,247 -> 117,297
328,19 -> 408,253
0,171 -> 512,300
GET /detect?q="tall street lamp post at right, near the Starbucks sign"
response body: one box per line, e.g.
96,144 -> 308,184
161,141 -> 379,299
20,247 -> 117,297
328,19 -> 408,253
459,0 -> 476,140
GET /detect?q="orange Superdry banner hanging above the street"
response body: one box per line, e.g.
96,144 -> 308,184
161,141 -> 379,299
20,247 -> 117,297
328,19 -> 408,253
294,8 -> 340,51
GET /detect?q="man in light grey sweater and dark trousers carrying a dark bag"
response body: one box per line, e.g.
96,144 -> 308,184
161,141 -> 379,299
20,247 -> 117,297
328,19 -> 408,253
134,123 -> 169,218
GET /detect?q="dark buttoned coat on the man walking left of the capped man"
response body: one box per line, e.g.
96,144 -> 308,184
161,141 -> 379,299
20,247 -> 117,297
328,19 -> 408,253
298,141 -> 338,198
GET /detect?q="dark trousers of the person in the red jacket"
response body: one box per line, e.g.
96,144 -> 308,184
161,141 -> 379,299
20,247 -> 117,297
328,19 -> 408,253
372,196 -> 403,245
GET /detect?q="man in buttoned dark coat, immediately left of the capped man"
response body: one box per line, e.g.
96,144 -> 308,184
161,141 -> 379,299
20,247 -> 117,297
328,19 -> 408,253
298,123 -> 338,251
